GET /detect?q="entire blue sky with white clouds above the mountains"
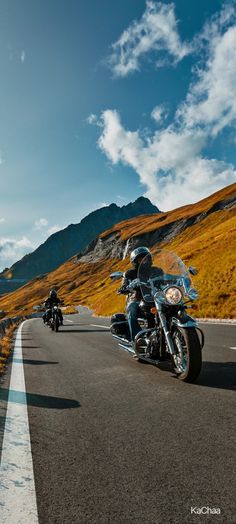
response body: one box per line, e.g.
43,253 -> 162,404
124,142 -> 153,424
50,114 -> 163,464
0,0 -> 236,269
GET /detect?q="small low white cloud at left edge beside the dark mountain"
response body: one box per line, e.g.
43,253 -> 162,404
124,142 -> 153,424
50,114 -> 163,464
0,237 -> 34,270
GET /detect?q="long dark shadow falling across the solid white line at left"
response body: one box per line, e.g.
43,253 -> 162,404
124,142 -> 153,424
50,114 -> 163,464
0,389 -> 80,409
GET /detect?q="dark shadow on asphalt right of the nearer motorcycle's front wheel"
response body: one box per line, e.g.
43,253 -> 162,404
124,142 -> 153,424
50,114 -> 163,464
196,361 -> 236,390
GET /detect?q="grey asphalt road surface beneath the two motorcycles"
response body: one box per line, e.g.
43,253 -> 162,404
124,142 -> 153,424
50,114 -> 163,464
0,314 -> 236,524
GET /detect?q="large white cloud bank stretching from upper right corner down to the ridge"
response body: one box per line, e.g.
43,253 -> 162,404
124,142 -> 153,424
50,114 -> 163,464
95,6 -> 236,210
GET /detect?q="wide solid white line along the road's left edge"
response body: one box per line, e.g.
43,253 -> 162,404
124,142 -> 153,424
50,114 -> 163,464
0,322 -> 38,524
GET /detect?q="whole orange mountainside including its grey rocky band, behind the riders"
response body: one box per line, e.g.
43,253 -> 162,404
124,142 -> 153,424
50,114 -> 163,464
0,184 -> 236,318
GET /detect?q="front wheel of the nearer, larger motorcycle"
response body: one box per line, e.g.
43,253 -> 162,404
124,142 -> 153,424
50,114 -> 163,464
172,326 -> 202,382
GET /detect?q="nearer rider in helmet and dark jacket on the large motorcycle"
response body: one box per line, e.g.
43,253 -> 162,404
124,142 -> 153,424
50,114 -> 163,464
118,247 -> 163,340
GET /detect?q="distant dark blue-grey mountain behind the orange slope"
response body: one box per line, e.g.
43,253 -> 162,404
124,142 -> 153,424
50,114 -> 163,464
0,197 -> 159,292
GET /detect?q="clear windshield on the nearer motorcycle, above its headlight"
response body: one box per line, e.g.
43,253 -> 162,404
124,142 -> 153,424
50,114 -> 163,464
138,249 -> 191,302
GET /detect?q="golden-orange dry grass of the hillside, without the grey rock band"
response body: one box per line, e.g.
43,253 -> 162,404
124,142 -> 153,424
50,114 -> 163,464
0,185 -> 236,318
